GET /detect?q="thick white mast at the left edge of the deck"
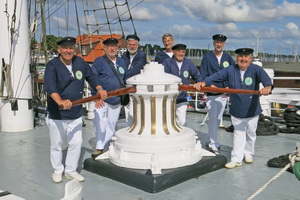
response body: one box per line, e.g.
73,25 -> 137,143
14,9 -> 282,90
0,0 -> 34,132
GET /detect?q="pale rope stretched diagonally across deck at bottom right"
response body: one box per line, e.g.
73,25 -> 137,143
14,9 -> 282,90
247,143 -> 300,200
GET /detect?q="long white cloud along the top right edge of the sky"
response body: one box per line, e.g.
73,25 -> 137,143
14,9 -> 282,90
175,0 -> 300,23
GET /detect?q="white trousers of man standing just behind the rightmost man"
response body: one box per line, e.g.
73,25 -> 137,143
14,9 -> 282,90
206,95 -> 228,148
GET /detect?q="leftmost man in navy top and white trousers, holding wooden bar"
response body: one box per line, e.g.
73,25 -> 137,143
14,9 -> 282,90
45,37 -> 107,183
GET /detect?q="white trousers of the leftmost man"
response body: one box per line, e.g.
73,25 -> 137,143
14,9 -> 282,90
46,117 -> 82,173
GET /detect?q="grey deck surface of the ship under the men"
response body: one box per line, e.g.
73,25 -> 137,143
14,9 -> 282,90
0,112 -> 300,200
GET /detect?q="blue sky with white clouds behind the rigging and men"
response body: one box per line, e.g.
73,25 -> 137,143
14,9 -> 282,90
31,0 -> 300,55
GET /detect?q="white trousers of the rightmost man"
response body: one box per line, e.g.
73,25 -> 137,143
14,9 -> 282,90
231,115 -> 259,162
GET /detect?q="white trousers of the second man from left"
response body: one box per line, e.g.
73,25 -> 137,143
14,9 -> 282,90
93,103 -> 121,150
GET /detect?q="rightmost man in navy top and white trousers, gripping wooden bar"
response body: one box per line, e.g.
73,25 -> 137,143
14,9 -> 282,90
194,48 -> 273,169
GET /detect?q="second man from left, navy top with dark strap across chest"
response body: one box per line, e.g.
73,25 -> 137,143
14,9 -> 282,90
92,38 -> 127,158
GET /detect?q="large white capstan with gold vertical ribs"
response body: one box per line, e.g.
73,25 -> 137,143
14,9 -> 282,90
104,62 -> 212,174
